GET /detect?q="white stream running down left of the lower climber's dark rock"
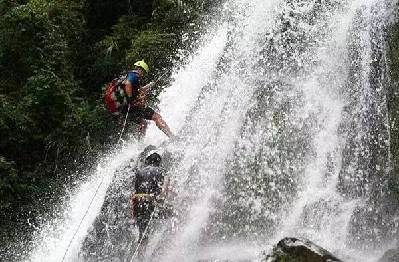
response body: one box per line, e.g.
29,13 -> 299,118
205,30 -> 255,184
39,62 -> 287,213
29,144 -> 140,262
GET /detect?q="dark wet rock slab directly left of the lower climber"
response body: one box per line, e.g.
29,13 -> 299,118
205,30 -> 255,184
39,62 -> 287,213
79,161 -> 137,262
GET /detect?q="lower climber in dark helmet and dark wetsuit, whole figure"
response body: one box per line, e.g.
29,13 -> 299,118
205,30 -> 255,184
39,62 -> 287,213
131,150 -> 169,242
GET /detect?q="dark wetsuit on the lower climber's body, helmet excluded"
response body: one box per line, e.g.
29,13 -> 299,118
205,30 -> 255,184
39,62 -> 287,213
133,166 -> 165,239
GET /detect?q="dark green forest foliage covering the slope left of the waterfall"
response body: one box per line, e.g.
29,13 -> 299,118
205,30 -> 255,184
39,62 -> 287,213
0,0 -> 222,252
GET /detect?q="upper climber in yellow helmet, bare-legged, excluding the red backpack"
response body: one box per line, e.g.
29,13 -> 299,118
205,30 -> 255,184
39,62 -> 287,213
123,60 -> 173,137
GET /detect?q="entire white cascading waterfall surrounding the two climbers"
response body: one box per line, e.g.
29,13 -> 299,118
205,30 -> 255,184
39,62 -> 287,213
23,0 -> 397,261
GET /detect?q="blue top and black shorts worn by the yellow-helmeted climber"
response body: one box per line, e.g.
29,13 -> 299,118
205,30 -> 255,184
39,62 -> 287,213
127,71 -> 155,123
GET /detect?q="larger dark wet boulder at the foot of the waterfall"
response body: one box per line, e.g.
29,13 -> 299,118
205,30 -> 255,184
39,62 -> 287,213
263,238 -> 342,262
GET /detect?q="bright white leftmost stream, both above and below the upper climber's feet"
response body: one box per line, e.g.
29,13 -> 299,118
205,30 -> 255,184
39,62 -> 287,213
28,16 -> 227,262
